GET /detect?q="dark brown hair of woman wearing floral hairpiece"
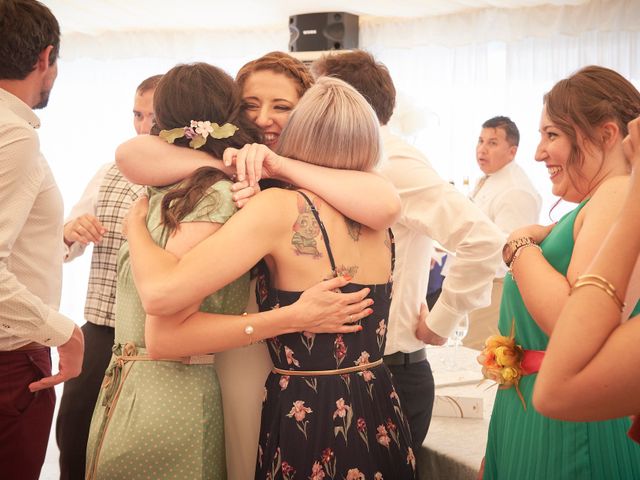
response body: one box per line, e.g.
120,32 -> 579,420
151,63 -> 259,231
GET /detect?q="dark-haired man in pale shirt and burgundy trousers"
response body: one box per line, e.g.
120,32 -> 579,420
0,0 -> 83,480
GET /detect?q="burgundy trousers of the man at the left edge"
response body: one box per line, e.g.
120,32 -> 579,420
0,347 -> 56,480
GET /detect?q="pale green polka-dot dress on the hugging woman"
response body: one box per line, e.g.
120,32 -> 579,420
86,180 -> 249,480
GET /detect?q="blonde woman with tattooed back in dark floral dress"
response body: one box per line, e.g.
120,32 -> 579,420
129,78 -> 415,479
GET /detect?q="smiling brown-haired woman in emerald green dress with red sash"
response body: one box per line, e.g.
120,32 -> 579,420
483,66 -> 640,480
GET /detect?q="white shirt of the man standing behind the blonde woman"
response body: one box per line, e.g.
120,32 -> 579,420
380,127 -> 504,346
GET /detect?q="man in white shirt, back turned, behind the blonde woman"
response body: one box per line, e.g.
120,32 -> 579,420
311,50 -> 503,450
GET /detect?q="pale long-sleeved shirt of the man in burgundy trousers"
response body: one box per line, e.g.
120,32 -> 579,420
0,88 -> 75,351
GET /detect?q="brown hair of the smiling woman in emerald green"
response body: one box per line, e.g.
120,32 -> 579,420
544,65 -> 640,194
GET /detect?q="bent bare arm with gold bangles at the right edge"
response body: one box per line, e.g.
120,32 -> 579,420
533,117 -> 640,436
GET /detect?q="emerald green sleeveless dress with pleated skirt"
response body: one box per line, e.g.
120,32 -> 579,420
484,200 -> 640,480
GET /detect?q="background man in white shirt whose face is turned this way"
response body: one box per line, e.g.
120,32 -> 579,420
464,117 -> 541,349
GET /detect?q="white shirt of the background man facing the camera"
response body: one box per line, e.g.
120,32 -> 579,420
473,161 -> 542,278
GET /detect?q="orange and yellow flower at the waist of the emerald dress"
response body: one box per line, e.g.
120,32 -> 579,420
478,319 -> 527,410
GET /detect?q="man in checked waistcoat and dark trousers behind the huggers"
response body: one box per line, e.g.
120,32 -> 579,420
56,75 -> 162,480
